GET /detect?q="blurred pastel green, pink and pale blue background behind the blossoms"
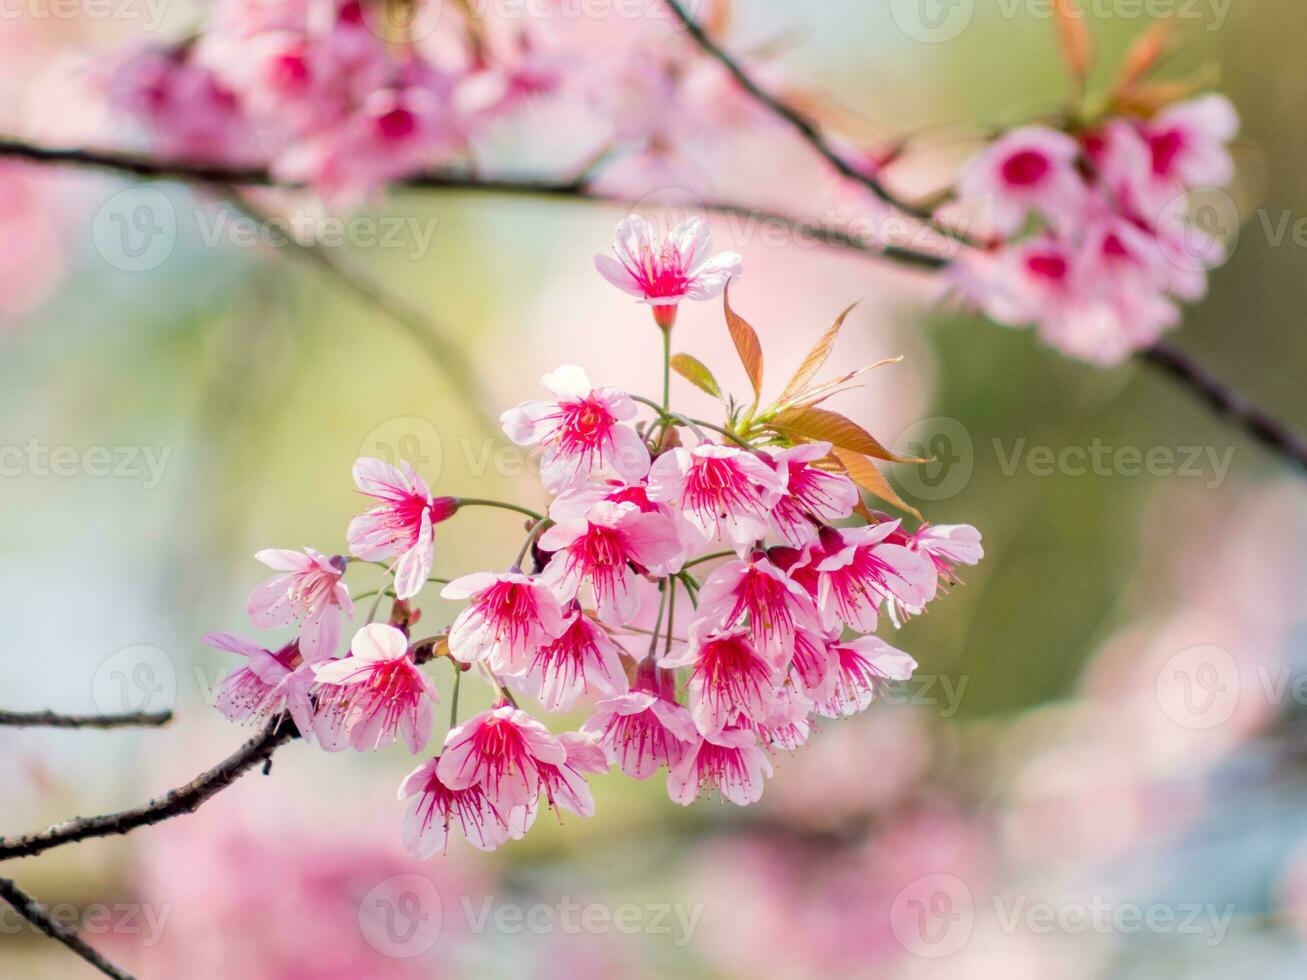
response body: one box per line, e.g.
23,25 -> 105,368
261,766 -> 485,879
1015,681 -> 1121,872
0,0 -> 1307,980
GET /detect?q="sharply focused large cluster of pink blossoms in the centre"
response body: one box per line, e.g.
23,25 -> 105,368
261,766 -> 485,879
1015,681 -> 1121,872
205,218 -> 982,856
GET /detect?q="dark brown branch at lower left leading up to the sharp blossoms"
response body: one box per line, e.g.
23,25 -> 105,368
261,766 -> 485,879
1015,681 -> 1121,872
0,717 -> 299,861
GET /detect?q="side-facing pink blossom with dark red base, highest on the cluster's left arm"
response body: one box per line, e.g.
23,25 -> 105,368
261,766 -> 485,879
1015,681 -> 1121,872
345,456 -> 457,598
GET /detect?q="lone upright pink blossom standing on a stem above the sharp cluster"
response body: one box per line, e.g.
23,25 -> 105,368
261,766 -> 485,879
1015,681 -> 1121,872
595,214 -> 744,329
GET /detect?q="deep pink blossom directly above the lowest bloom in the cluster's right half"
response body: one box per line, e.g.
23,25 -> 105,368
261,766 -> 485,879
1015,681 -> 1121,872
660,627 -> 779,734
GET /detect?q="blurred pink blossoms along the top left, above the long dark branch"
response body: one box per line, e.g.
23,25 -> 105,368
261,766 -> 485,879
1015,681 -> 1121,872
103,0 -> 761,203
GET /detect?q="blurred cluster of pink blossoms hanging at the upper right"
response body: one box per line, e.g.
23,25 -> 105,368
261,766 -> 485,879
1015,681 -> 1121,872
951,95 -> 1239,365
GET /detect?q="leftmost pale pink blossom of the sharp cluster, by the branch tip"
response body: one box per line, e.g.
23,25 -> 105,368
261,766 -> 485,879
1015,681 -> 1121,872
203,632 -> 312,737
